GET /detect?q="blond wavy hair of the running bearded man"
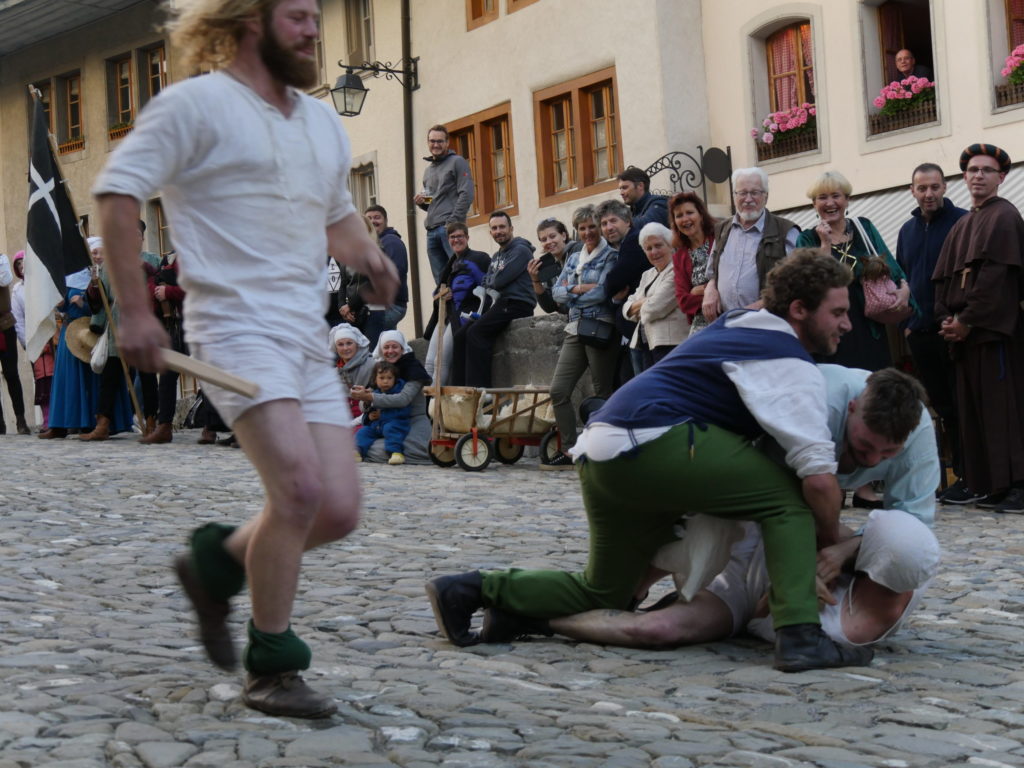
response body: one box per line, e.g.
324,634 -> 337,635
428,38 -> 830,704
164,0 -> 280,70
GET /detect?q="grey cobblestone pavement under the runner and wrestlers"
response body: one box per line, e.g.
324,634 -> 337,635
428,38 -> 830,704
0,432 -> 1024,768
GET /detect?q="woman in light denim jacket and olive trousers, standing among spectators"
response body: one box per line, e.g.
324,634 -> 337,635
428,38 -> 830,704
541,206 -> 620,469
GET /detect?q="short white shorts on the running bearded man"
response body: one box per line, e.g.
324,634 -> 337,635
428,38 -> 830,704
188,334 -> 352,427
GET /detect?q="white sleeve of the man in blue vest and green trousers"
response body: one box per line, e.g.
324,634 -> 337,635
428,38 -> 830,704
722,357 -> 838,478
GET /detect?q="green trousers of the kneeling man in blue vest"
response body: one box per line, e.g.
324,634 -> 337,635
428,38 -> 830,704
483,424 -> 818,628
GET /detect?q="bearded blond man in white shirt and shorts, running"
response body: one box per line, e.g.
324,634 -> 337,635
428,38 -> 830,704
93,0 -> 397,718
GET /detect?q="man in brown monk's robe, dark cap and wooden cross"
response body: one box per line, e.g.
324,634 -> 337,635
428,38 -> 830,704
932,144 -> 1024,514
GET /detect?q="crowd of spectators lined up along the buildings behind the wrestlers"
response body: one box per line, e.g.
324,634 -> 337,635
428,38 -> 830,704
0,125 -> 1024,512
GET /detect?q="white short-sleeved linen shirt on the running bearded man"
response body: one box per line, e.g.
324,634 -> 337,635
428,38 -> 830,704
92,72 -> 355,360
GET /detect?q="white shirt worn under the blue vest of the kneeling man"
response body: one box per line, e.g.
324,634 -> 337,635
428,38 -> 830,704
571,309 -> 839,479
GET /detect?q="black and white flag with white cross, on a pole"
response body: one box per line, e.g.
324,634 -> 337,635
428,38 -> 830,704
25,92 -> 91,360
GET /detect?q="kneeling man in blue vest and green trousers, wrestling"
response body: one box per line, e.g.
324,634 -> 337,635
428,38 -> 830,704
426,249 -> 871,672
